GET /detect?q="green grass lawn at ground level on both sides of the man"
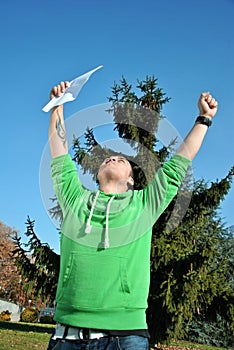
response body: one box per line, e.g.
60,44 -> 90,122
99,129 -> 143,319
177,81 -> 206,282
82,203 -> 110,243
0,321 -> 230,350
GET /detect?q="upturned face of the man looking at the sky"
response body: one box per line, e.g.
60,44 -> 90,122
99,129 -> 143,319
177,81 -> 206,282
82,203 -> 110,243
98,156 -> 133,185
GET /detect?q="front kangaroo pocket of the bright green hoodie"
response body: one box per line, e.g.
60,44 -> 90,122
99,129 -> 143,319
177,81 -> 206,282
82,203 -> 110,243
57,253 -> 130,309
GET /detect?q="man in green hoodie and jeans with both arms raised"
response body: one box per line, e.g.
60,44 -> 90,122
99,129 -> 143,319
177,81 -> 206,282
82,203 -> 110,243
48,82 -> 218,350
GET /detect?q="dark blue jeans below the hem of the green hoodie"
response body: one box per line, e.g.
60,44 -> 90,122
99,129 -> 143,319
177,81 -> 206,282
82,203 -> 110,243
47,335 -> 149,350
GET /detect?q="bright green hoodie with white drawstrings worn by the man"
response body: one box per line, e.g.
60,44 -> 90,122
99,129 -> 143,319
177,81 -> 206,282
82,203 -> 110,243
51,155 -> 190,330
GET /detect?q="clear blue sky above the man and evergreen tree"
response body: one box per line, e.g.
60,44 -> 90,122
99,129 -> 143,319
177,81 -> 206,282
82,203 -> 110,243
0,0 -> 234,251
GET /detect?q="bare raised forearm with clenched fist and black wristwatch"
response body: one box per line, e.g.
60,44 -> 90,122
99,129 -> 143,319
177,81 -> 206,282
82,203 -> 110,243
177,92 -> 218,160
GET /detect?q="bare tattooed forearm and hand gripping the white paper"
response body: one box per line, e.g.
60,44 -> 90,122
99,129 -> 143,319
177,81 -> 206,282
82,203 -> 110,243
49,82 -> 69,158
